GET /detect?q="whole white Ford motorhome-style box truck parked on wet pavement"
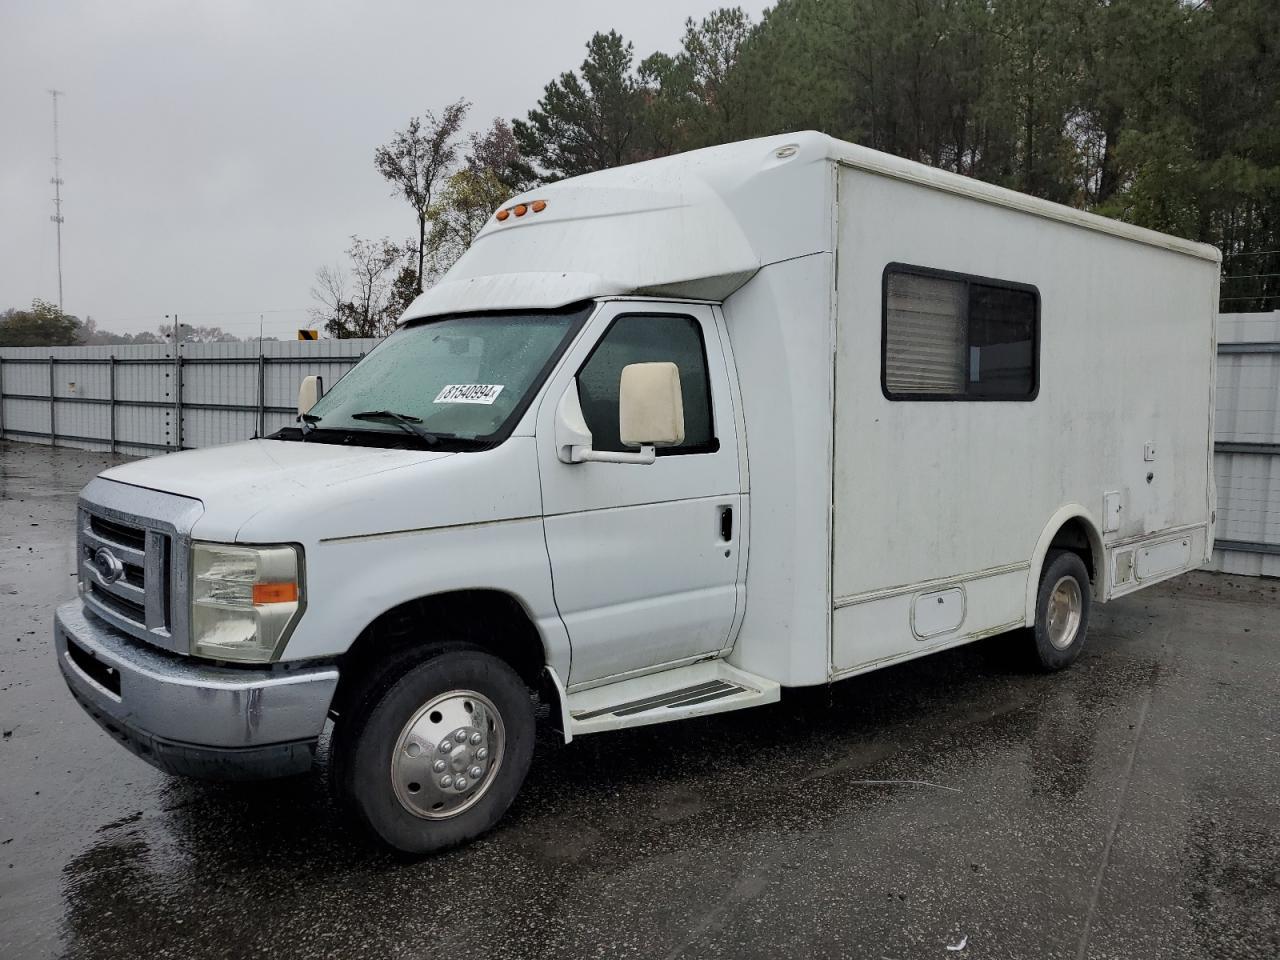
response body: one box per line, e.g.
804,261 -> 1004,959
55,133 -> 1220,852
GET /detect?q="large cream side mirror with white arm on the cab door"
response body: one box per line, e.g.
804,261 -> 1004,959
556,362 -> 685,463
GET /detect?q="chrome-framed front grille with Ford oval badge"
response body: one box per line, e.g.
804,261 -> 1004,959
77,479 -> 201,653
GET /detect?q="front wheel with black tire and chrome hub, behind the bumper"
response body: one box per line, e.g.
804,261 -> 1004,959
332,650 -> 534,854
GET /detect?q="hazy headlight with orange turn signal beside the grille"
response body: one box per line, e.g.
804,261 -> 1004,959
191,543 -> 303,662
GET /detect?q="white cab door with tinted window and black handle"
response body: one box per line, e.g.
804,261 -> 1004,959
538,301 -> 746,685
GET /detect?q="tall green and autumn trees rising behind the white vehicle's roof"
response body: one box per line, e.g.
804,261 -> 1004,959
315,0 -> 1280,337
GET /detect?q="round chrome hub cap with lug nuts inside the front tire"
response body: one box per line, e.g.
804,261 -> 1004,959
390,690 -> 507,819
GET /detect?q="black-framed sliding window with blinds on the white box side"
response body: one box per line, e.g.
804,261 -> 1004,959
881,264 -> 1039,401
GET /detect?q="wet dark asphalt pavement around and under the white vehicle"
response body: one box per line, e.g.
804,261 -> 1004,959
0,444 -> 1280,960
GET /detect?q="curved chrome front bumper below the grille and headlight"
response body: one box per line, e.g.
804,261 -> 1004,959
54,600 -> 338,780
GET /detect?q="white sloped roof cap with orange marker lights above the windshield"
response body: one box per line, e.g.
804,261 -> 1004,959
404,133 -> 831,317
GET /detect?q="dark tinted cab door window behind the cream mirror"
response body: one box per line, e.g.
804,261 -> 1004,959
577,314 -> 719,456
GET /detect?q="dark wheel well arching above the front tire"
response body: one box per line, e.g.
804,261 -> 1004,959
329,590 -> 547,716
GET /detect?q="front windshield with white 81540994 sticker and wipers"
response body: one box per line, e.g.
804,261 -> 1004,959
295,305 -> 591,448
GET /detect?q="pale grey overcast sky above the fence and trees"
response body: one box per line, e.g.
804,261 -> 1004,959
0,0 -> 765,337
